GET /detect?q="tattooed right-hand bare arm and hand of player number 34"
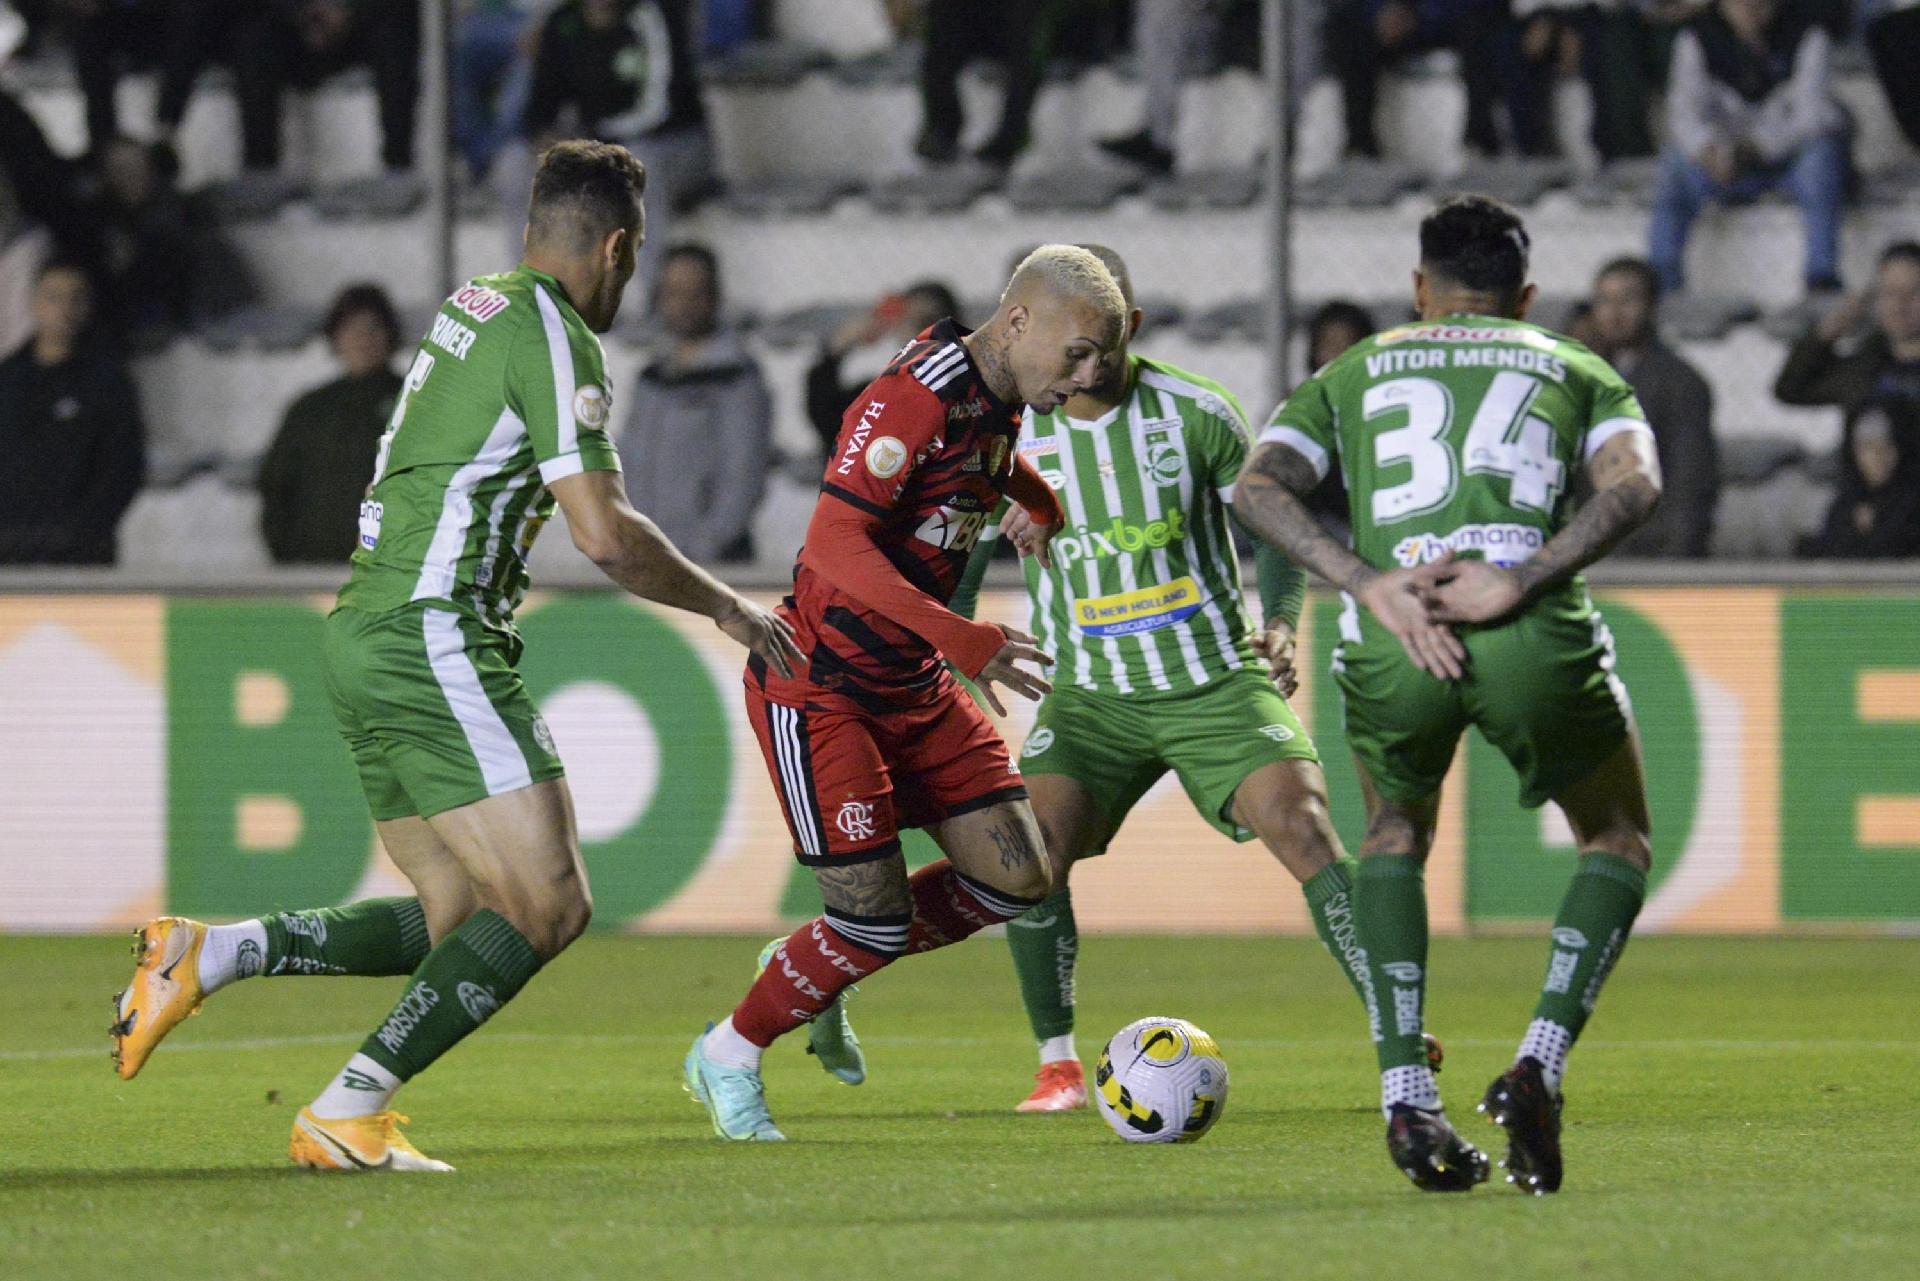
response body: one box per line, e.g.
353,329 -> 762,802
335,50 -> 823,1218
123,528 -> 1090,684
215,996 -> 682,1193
1432,430 -> 1661,622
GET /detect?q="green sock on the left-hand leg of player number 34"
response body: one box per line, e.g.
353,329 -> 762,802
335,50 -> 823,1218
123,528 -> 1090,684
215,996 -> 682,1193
1354,855 -> 1427,1072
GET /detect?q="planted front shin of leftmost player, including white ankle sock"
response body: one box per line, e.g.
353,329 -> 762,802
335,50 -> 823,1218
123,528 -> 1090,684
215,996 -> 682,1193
313,908 -> 541,1120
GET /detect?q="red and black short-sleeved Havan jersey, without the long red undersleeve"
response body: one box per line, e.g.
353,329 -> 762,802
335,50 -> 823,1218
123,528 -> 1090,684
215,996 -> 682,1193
783,321 -> 1020,701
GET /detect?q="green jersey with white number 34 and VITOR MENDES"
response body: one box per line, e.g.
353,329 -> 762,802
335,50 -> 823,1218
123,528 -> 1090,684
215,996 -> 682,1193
1260,315 -> 1651,599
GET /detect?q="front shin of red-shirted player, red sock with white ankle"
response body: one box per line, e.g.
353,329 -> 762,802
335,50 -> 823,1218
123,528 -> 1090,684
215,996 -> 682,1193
721,908 -> 908,1070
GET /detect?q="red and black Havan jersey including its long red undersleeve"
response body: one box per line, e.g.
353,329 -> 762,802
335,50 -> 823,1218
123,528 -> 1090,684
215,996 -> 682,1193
781,321 -> 1021,701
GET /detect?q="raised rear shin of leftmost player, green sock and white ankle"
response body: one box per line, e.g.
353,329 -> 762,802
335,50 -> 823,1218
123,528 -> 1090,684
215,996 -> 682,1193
200,899 -> 430,993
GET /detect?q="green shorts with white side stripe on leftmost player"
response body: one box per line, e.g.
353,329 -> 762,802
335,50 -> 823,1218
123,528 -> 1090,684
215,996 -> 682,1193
326,603 -> 564,822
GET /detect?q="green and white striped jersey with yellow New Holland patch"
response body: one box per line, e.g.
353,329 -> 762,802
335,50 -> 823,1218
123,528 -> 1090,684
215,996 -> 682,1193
987,355 -> 1258,693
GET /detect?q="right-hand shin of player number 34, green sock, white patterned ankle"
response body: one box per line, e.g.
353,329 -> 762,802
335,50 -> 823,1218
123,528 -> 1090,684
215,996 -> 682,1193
1517,853 -> 1647,1091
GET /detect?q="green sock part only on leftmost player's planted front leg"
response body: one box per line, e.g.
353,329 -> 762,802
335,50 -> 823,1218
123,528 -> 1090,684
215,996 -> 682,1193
361,908 -> 540,1081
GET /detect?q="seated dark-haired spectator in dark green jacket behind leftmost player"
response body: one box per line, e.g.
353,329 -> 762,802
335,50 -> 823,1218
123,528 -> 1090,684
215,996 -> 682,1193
259,284 -> 401,565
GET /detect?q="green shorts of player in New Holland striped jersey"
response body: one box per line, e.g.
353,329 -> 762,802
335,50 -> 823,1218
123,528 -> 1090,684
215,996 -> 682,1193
1020,668 -> 1319,853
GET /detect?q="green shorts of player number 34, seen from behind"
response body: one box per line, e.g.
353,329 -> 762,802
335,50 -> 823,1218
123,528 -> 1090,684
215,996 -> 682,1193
1334,592 -> 1634,809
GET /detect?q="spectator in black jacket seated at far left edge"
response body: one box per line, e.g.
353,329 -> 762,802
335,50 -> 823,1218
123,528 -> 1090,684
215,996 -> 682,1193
0,259 -> 146,565
